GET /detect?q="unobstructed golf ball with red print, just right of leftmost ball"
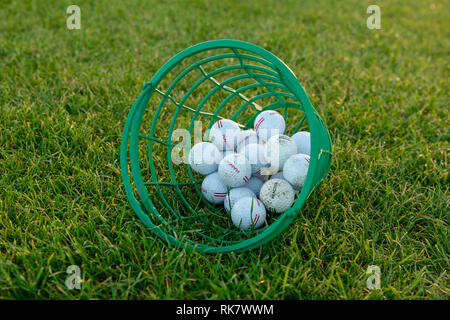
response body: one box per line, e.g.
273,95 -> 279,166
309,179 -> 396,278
218,153 -> 252,188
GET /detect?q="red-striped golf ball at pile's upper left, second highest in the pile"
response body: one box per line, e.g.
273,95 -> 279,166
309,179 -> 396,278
209,119 -> 241,150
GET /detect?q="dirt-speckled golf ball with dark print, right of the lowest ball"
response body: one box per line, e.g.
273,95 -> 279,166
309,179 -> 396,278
259,179 -> 294,213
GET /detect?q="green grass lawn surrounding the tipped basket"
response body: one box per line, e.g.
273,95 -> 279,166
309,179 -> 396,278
0,0 -> 450,299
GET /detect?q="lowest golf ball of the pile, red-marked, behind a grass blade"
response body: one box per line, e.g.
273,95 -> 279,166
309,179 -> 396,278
231,197 -> 266,231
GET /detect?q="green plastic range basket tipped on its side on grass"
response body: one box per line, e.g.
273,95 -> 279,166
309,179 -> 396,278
120,40 -> 331,253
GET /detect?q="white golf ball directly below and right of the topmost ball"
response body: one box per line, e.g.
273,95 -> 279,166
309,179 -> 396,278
264,134 -> 297,172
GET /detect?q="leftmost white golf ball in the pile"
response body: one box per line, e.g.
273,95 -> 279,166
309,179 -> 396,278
188,142 -> 222,174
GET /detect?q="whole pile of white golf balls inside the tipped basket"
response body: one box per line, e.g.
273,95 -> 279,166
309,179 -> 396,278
188,110 -> 311,231
